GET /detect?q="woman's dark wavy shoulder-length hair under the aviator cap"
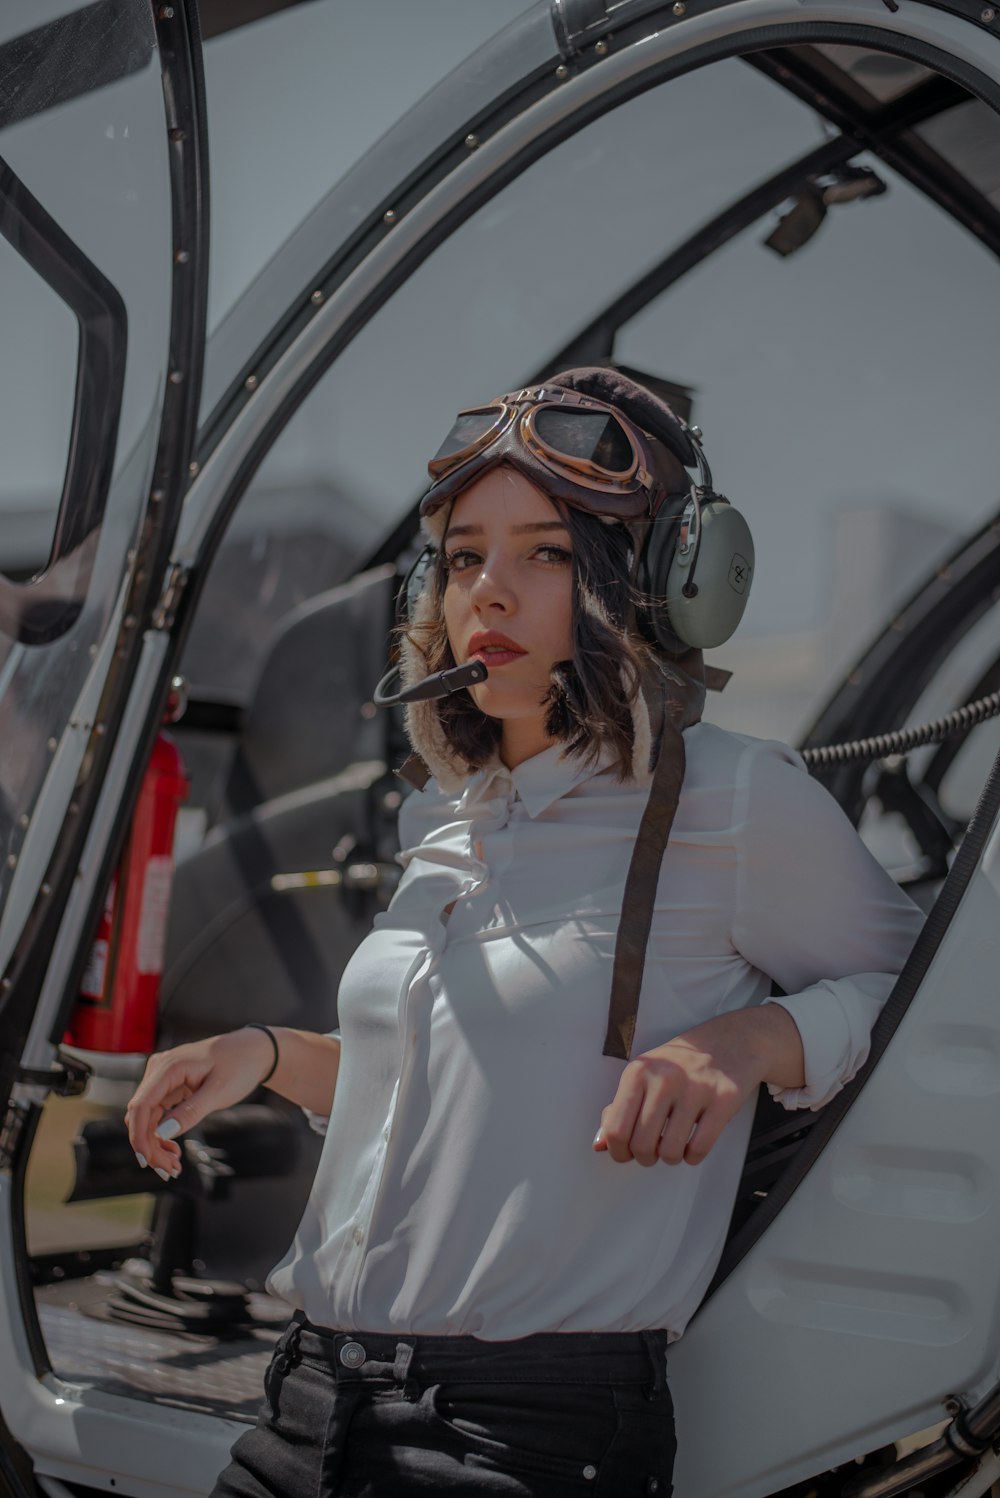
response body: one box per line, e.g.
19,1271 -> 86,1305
401,499 -> 653,780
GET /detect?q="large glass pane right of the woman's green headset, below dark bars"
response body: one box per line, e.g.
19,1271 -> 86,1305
618,140 -> 1000,740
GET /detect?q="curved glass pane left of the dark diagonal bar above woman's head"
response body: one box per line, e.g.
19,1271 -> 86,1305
184,61 -> 817,700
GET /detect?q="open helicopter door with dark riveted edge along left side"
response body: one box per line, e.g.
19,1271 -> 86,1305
0,0 -> 207,1491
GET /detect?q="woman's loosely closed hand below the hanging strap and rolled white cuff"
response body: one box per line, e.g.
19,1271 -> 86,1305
594,1004 -> 805,1165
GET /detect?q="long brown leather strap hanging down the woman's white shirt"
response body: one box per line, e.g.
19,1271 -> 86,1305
603,715 -> 684,1061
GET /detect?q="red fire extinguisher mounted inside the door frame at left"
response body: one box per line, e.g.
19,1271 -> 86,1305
64,710 -> 190,1055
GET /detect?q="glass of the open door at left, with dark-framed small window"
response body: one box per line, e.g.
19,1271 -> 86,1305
0,0 -> 171,960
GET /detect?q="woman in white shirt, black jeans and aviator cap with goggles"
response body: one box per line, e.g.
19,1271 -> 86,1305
129,372 -> 919,1498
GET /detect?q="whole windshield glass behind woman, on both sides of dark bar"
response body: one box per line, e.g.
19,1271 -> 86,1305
186,48 -> 1000,754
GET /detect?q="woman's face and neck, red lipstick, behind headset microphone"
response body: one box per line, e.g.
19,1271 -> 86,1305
443,466 -> 573,768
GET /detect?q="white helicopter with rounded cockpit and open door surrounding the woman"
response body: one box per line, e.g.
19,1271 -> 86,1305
0,0 -> 1000,1498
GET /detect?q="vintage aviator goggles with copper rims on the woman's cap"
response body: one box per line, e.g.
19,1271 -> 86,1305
421,385 -> 711,521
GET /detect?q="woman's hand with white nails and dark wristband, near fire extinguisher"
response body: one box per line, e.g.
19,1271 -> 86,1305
126,1029 -> 274,1180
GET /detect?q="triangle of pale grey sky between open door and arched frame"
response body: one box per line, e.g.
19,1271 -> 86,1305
197,0 -> 528,333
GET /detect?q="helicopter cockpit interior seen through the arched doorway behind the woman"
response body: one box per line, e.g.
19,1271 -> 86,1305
15,5 -> 1000,1468
